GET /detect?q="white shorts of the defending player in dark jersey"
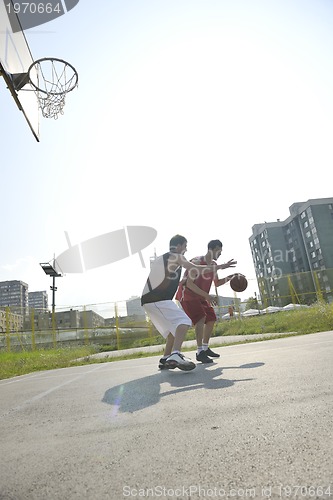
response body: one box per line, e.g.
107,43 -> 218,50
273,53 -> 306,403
143,300 -> 192,339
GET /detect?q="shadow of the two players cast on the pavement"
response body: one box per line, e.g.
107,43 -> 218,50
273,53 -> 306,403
102,363 -> 265,414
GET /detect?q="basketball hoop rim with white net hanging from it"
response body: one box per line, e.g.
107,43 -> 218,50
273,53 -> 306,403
28,57 -> 79,119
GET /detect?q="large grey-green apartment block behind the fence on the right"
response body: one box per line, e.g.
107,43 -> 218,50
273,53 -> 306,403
249,198 -> 333,306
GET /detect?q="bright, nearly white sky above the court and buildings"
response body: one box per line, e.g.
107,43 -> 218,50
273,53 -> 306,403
0,0 -> 333,316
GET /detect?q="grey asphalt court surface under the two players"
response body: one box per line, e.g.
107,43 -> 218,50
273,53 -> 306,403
0,332 -> 333,500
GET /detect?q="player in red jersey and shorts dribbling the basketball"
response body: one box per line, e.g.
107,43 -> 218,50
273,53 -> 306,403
176,240 -> 237,363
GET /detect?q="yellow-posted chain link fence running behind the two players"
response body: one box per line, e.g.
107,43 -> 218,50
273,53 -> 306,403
0,269 -> 333,352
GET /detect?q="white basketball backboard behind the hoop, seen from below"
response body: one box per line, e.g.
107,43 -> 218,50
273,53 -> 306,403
0,0 -> 39,141
